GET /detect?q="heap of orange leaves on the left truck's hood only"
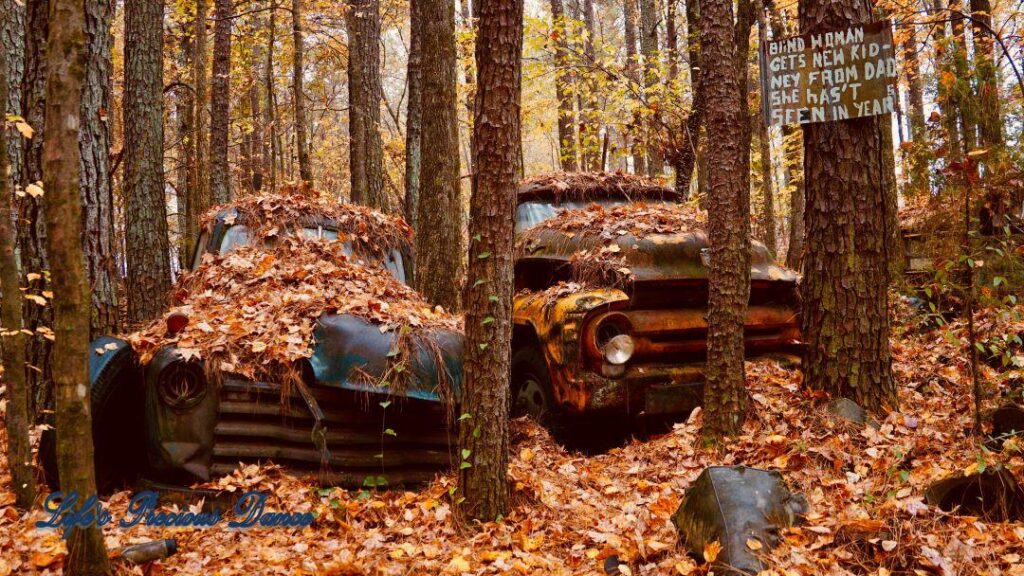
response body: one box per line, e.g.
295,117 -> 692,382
128,230 -> 460,381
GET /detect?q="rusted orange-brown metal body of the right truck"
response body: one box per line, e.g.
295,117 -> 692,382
513,175 -> 803,416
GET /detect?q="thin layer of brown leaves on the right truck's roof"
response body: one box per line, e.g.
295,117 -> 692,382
519,172 -> 676,199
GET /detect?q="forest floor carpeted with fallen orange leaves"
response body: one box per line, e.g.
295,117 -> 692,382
0,303 -> 1024,576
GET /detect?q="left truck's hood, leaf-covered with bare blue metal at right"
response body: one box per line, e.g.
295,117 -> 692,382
128,230 -> 462,397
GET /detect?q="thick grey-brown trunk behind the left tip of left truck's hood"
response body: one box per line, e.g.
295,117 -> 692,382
124,0 -> 171,323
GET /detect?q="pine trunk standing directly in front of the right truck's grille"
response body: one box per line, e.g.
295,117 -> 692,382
700,0 -> 751,441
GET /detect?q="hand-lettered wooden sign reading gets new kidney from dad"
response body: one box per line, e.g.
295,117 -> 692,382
761,20 -> 896,126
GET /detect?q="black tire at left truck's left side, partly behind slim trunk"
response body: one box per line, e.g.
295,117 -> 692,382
39,339 -> 145,494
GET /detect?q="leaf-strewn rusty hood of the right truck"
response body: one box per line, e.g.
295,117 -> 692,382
517,203 -> 797,286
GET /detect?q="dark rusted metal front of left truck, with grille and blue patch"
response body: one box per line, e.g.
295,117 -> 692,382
77,206 -> 463,487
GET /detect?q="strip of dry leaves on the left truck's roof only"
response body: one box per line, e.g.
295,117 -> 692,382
203,182 -> 413,256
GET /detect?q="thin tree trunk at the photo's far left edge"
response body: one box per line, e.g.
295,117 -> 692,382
0,40 -> 36,510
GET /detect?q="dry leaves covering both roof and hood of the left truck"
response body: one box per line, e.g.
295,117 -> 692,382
127,190 -> 461,380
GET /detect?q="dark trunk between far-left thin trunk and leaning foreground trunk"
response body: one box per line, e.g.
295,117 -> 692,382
17,0 -> 53,418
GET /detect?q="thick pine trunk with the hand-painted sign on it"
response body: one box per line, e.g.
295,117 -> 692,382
800,0 -> 896,410
